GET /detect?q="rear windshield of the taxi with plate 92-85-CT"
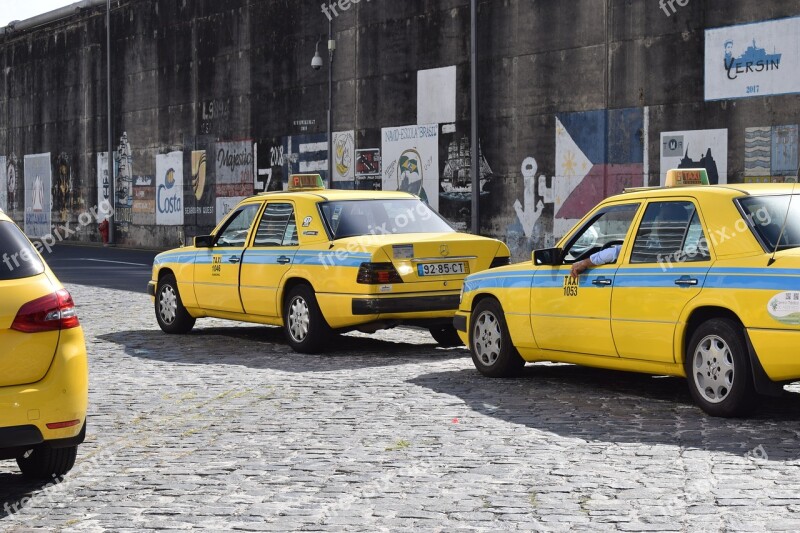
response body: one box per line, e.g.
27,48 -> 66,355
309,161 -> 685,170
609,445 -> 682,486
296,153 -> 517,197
320,198 -> 455,239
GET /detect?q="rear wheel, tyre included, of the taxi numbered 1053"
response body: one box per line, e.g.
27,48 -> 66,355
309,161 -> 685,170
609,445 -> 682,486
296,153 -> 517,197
685,318 -> 754,417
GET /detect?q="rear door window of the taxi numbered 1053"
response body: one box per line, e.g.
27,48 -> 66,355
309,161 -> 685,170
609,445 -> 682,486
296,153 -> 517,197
631,201 -> 709,263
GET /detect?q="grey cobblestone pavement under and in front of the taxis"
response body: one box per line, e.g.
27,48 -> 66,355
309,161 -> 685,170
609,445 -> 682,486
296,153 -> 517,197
0,285 -> 800,531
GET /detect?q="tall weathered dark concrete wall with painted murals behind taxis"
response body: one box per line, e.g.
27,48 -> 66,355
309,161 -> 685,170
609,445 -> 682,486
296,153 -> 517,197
0,0 -> 800,259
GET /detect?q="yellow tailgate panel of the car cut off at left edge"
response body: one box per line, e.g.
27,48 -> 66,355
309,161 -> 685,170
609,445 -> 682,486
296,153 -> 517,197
0,273 -> 60,387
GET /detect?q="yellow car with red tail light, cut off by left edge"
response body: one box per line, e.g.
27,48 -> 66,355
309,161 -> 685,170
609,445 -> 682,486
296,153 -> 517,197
0,210 -> 89,474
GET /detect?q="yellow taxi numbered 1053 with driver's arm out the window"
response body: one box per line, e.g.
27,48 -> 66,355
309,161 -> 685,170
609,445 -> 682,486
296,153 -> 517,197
454,169 -> 800,416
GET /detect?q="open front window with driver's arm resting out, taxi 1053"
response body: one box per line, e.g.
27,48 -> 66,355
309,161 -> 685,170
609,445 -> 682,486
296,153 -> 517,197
564,203 -> 639,263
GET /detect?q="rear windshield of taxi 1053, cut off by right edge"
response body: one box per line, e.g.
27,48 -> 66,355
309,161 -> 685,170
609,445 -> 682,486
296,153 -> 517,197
739,194 -> 800,252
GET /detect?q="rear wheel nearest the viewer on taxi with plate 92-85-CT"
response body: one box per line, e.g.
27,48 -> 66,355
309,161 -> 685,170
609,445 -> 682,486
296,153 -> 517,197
283,285 -> 333,353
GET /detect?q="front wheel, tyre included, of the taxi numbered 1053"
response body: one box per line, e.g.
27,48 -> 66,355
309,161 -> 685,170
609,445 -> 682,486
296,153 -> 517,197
469,300 -> 525,378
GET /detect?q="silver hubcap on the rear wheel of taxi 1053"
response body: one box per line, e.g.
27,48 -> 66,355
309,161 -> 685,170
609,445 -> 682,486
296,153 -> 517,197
692,335 -> 734,403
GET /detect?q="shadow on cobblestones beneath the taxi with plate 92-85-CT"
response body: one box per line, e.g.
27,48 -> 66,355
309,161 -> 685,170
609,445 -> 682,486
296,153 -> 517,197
98,326 -> 468,372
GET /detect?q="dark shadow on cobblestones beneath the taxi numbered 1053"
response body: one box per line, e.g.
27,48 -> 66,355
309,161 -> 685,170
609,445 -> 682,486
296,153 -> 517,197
409,365 -> 800,461
